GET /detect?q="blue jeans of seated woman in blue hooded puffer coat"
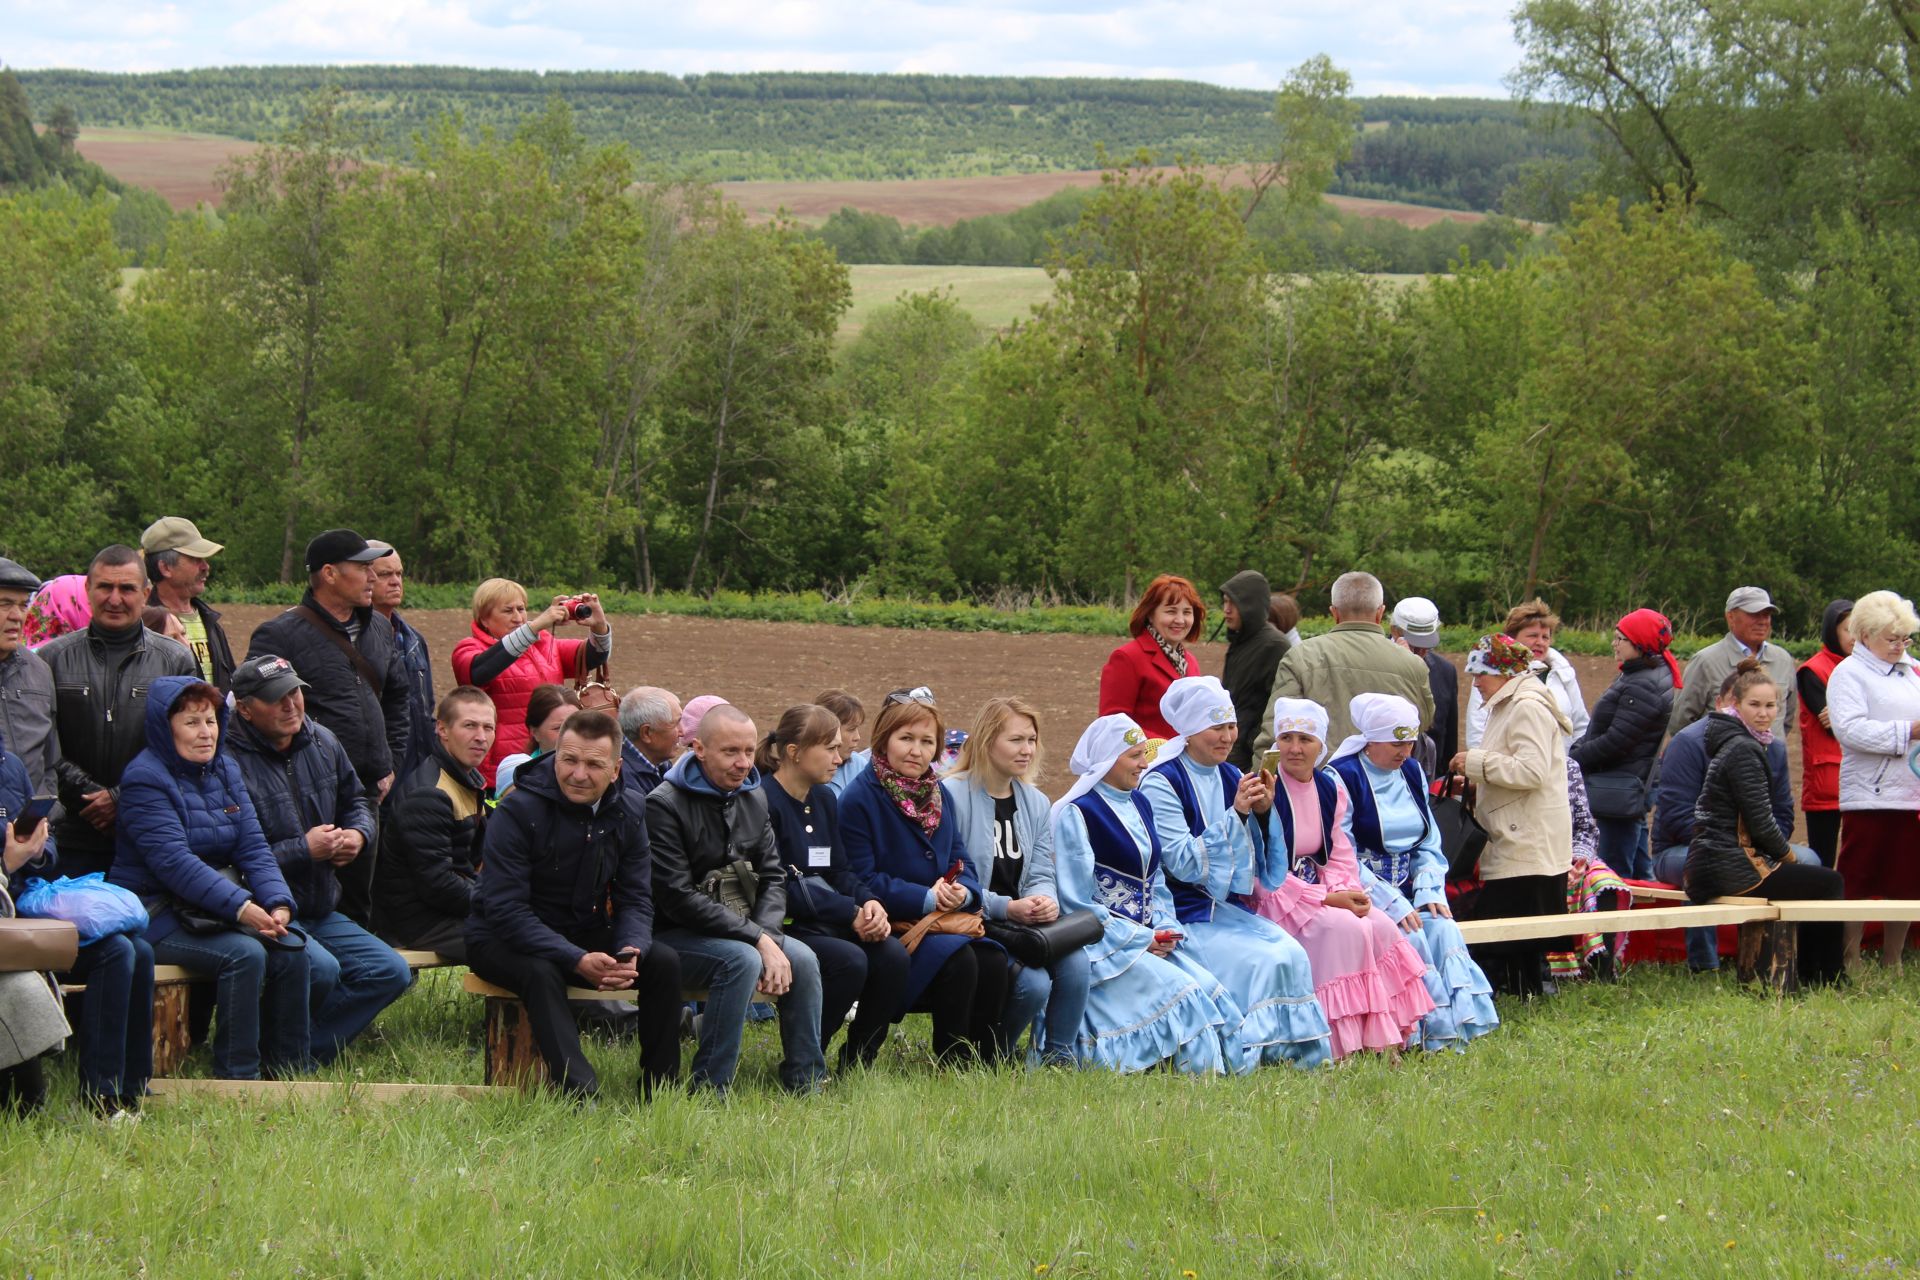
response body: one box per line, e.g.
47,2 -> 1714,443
154,929 -> 311,1080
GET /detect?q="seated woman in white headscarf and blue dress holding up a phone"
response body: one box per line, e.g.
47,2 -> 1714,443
1140,676 -> 1332,1067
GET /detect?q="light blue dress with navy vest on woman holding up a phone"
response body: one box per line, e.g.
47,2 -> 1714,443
1140,752 -> 1332,1067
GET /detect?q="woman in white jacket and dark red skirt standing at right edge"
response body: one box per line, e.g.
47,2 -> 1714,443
1826,591 -> 1920,969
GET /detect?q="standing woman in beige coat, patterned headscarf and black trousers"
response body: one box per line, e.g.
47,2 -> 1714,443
1450,635 -> 1572,996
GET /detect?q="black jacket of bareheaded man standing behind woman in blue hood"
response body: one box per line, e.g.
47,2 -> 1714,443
38,626 -> 200,875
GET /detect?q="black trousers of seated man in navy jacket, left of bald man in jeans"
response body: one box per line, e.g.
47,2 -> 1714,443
467,938 -> 685,1098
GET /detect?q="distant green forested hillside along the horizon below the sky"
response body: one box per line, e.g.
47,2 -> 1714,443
7,67 -> 1592,217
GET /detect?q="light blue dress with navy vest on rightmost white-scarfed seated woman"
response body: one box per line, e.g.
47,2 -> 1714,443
1332,752 -> 1500,1050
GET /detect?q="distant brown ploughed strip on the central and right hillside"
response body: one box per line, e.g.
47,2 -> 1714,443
720,169 -> 1486,228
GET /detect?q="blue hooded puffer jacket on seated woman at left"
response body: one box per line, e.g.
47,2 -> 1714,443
108,676 -> 294,942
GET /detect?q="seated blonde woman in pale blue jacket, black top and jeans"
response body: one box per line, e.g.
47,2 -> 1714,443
947,699 -> 1092,1067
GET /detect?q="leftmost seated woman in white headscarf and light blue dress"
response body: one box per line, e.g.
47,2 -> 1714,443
1052,716 -> 1244,1075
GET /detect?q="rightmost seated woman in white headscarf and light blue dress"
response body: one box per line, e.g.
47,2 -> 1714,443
1329,693 -> 1500,1050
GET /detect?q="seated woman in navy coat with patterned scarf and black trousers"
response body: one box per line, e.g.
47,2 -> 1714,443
839,689 -> 1006,1063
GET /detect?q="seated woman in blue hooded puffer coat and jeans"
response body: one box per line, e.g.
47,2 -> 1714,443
109,676 -> 311,1080
